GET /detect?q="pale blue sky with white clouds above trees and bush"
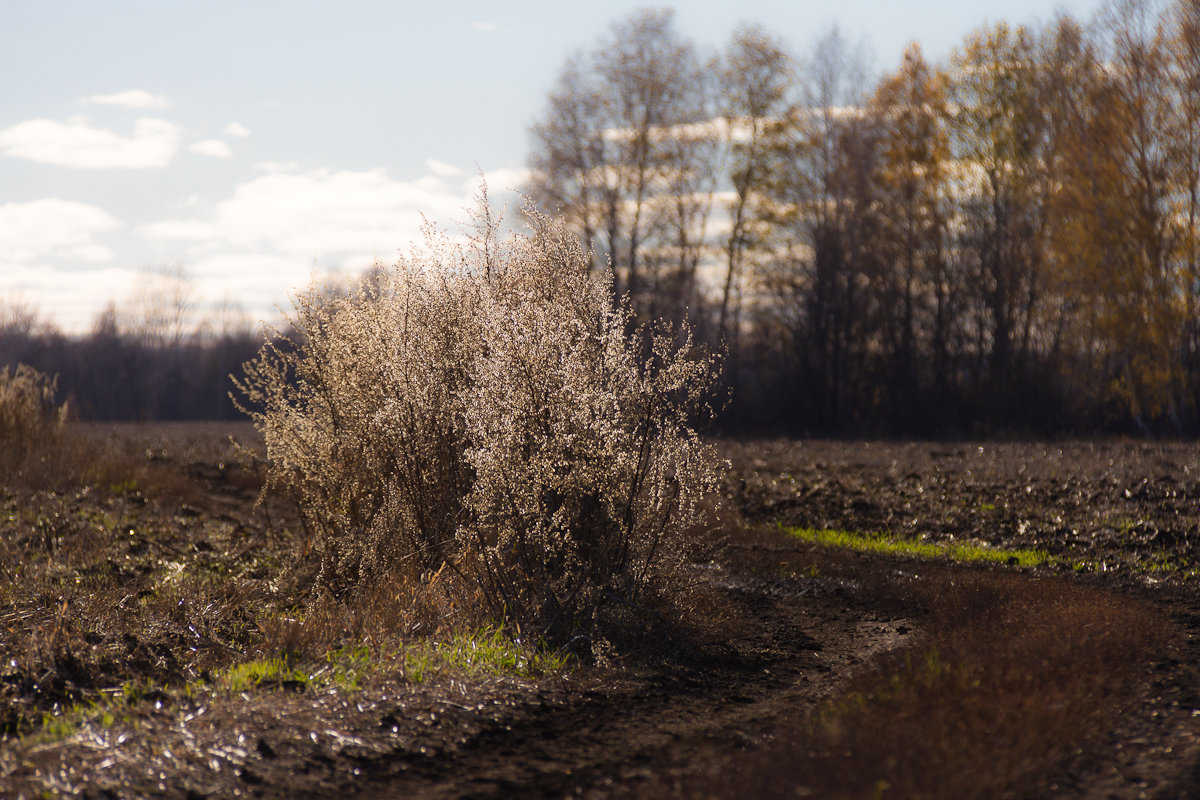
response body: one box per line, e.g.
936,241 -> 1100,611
0,0 -> 1100,333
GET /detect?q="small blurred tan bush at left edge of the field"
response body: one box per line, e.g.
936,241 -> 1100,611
0,363 -> 70,483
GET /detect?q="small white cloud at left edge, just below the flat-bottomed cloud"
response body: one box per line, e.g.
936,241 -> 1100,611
0,198 -> 121,263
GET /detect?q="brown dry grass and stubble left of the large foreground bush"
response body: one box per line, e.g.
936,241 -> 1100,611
0,419 -> 295,736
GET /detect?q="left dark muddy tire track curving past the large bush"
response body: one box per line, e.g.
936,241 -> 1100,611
346,566 -> 911,799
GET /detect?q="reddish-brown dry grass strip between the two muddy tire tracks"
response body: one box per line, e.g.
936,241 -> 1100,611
702,556 -> 1171,800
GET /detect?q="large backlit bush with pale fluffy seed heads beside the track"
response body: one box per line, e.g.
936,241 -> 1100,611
235,198 -> 715,639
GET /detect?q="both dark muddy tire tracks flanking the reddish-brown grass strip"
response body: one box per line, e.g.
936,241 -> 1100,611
347,545 -> 1200,800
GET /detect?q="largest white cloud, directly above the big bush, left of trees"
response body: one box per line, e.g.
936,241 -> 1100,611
124,164 -> 524,331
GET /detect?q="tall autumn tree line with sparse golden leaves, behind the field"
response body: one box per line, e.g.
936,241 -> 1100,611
527,0 -> 1200,434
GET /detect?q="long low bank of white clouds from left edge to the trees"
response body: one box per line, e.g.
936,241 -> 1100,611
0,162 -> 526,332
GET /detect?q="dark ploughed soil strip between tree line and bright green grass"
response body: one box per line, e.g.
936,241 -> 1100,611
726,440 -> 1200,579
